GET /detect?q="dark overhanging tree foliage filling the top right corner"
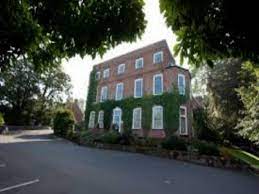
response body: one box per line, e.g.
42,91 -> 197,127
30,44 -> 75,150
160,0 -> 259,66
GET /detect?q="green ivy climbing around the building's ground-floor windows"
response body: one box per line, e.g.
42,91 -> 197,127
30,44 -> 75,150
86,83 -> 189,136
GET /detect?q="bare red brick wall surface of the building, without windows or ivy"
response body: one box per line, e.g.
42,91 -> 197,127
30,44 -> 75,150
89,40 -> 192,137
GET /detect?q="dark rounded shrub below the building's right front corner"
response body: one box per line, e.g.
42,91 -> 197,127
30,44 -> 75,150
161,136 -> 187,151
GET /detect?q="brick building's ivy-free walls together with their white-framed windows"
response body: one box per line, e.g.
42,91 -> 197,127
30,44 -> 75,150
88,40 -> 192,138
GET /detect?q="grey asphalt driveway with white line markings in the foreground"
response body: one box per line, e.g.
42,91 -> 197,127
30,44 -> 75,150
0,131 -> 259,194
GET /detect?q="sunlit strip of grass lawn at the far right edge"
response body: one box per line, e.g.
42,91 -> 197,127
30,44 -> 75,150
221,147 -> 259,169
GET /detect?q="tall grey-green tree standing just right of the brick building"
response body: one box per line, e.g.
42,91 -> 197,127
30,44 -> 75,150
207,59 -> 245,138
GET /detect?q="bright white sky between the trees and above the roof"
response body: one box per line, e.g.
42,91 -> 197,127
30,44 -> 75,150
62,0 -> 188,99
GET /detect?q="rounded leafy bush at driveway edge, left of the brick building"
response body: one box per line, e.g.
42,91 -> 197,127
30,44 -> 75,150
53,109 -> 75,137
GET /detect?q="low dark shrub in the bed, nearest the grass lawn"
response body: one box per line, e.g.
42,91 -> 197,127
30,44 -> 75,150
191,140 -> 220,156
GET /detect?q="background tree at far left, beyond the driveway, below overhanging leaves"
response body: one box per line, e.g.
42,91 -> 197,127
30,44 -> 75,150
0,59 -> 70,125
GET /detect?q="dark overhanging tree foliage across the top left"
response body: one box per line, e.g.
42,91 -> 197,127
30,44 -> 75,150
0,0 -> 146,67
